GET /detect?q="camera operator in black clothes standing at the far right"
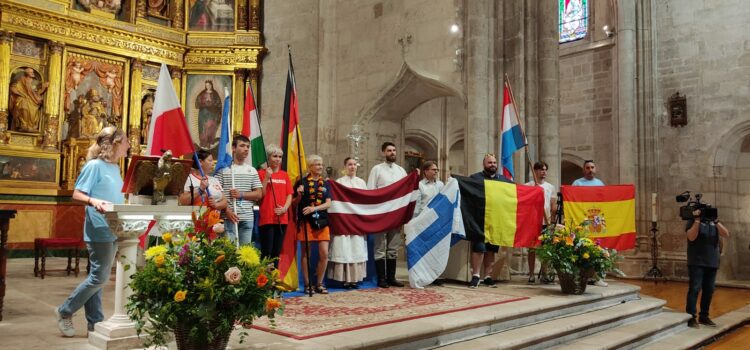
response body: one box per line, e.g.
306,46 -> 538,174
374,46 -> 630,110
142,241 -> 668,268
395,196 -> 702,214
685,209 -> 729,328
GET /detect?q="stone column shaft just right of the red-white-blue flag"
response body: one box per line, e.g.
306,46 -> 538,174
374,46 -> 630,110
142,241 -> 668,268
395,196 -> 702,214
536,2 -> 561,188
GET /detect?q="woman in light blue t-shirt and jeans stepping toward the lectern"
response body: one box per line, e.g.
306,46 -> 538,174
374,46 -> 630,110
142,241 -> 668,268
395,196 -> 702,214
57,126 -> 130,337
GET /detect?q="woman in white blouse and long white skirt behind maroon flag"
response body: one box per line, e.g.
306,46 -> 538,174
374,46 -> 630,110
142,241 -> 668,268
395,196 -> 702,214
328,157 -> 367,289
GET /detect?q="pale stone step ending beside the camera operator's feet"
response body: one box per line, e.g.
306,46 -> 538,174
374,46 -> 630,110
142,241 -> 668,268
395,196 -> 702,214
552,310 -> 690,350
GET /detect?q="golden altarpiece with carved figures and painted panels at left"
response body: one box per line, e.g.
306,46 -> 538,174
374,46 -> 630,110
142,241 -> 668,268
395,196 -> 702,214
0,0 -> 265,247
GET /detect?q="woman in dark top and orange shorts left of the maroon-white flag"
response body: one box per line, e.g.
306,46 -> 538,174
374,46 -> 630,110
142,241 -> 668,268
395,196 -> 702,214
294,154 -> 331,294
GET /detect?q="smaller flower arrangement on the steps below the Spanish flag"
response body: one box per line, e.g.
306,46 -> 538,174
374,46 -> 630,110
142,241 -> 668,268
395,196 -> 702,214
536,222 -> 619,282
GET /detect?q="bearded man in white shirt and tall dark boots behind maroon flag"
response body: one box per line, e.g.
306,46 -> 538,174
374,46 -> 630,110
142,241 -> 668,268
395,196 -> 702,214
367,142 -> 406,288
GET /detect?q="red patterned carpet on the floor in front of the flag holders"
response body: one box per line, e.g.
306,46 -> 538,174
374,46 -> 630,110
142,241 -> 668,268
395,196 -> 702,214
253,287 -> 528,340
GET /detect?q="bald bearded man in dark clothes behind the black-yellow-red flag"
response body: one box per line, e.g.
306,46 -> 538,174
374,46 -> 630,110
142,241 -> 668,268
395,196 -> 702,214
467,153 -> 512,288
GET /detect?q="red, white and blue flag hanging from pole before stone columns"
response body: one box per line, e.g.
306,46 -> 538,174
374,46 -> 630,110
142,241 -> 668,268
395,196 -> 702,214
500,82 -> 526,181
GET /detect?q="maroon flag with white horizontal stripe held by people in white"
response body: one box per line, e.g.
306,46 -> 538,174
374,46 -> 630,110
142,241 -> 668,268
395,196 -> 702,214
328,171 -> 419,235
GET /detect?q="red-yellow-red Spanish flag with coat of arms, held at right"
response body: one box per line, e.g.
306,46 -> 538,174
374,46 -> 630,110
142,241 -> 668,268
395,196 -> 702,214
562,185 -> 635,250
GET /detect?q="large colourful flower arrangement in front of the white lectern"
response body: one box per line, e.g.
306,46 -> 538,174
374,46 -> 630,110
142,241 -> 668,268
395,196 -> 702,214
126,211 -> 283,348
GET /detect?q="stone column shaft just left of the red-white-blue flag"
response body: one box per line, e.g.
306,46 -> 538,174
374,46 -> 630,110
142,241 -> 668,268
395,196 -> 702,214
464,0 -> 499,173
